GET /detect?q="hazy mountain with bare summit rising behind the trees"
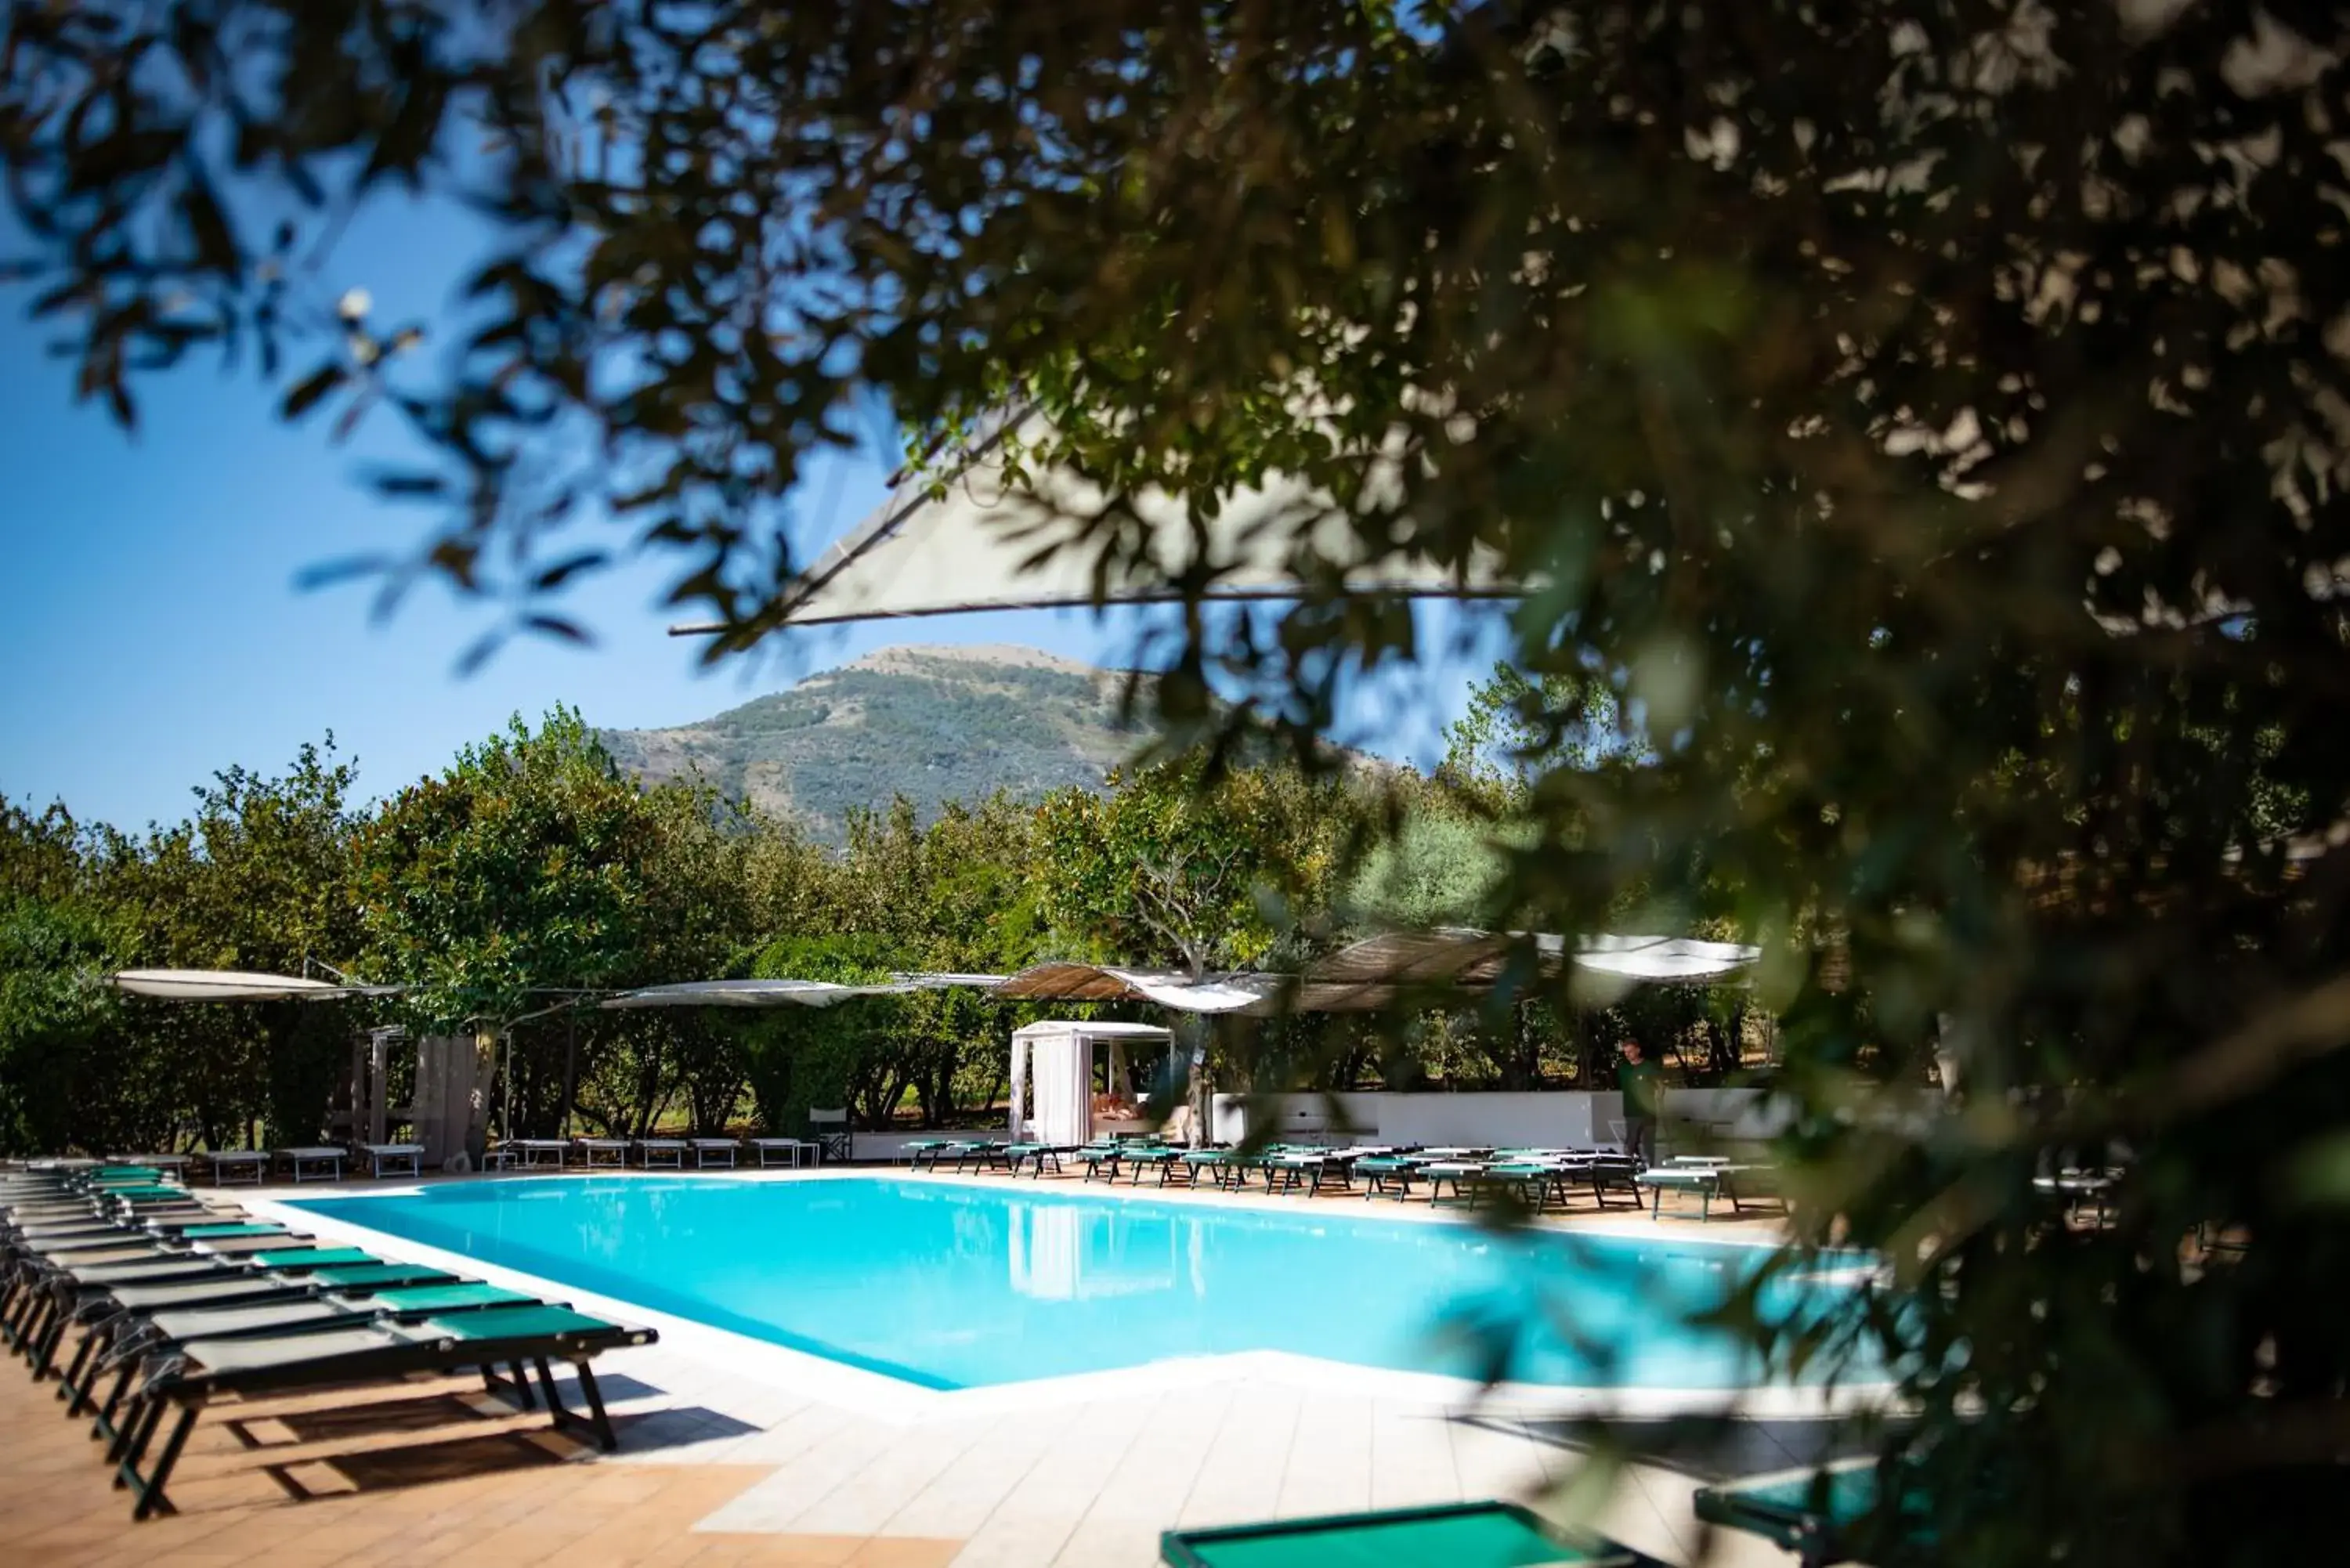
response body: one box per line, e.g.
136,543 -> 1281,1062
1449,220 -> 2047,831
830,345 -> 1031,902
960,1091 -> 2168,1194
602,646 -> 1144,844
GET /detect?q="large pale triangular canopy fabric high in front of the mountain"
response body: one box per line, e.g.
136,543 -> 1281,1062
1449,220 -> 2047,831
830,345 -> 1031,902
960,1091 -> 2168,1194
672,414 -> 1523,634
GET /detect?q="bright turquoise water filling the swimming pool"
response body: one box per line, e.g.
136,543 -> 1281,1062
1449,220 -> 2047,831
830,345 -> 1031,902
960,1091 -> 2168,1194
284,1178 -> 1849,1389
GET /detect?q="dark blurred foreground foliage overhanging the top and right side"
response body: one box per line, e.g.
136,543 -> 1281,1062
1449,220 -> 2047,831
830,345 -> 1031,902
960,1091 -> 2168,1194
0,0 -> 2350,1566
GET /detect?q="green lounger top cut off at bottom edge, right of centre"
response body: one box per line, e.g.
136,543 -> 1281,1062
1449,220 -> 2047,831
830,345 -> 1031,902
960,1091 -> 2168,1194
1159,1502 -> 1654,1568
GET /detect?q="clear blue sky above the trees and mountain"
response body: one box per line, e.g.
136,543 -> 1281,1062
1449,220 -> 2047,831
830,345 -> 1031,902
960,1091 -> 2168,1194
0,196 -> 1504,828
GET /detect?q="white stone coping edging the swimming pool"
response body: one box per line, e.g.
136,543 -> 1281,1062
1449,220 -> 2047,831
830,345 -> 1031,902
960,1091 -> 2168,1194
240,1169 -> 1892,1425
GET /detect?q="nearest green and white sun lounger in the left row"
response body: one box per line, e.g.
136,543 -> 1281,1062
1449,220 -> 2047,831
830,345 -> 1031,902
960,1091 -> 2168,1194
108,1307 -> 656,1519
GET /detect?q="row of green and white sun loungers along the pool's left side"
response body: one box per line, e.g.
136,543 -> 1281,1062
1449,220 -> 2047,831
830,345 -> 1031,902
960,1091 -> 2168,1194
0,1164 -> 653,1519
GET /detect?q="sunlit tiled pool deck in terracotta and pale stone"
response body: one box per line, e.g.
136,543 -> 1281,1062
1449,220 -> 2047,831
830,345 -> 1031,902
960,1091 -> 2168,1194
0,1173 -> 1798,1568
